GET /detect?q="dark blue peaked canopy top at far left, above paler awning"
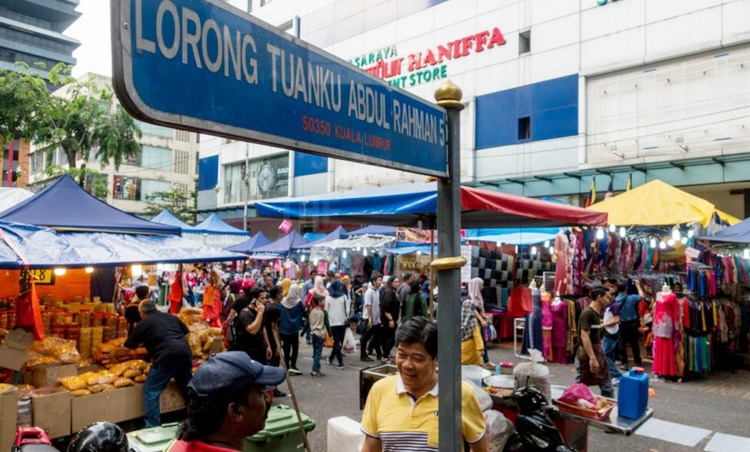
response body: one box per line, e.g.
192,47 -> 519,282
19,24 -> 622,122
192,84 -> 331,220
0,175 -> 181,235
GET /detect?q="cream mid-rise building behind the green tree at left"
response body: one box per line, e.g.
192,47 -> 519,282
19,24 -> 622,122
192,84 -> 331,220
29,74 -> 200,214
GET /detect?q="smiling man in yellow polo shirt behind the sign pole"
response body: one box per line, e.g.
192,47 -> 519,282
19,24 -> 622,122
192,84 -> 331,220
362,317 -> 489,452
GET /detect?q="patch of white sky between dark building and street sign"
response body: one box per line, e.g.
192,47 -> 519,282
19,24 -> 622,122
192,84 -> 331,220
65,0 -> 112,77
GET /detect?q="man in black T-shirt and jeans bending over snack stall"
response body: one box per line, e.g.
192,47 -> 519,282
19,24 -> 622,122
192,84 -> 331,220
112,300 -> 193,428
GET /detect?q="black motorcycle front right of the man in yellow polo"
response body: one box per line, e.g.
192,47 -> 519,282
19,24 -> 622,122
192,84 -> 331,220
503,383 -> 576,452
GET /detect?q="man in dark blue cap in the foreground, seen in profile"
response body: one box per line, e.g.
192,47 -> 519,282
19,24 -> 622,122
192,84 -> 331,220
166,352 -> 286,452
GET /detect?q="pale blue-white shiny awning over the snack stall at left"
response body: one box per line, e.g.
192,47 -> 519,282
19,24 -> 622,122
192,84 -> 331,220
0,221 -> 245,269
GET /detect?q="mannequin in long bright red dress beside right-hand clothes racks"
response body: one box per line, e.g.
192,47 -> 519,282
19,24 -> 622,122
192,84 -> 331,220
652,284 -> 680,377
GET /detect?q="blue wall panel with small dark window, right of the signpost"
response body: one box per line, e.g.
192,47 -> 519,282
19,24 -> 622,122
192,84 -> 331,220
476,74 -> 578,150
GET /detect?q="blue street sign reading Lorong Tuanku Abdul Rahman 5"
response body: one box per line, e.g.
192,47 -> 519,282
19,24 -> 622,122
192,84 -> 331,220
111,0 -> 447,176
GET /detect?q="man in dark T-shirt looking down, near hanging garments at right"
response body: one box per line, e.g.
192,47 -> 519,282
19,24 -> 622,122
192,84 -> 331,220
576,286 -> 615,397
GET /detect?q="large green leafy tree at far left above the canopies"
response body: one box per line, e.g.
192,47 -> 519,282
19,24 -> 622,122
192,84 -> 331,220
0,64 -> 142,169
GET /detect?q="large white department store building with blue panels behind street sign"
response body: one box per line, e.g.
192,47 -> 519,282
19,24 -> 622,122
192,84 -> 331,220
198,0 -> 750,228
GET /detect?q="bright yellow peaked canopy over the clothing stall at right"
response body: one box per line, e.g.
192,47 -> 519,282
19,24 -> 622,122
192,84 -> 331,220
589,180 -> 740,227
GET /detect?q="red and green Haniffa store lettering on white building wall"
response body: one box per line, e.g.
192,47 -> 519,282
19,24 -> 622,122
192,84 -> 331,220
349,27 -> 505,88
